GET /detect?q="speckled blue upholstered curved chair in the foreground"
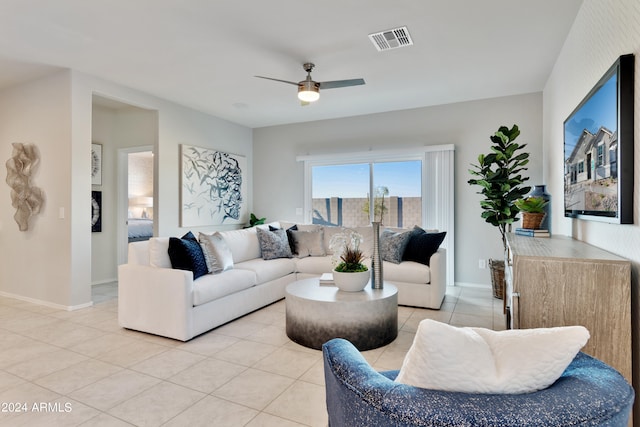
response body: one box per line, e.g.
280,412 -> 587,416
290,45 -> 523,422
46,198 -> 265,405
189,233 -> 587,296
322,338 -> 634,427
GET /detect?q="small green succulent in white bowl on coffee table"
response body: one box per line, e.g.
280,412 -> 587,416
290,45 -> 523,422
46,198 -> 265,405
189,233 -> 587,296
329,230 -> 370,292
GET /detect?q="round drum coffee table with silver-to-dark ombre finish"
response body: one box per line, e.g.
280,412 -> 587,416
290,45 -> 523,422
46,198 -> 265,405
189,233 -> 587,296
285,278 -> 398,351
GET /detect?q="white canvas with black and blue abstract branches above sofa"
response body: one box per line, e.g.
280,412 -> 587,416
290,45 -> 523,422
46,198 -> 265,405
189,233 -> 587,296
180,144 -> 248,227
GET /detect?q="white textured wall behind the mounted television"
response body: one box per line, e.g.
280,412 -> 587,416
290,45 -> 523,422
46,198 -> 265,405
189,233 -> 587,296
544,0 -> 640,420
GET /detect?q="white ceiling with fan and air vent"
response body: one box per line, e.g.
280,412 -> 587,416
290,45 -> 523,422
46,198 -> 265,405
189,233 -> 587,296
0,0 -> 582,127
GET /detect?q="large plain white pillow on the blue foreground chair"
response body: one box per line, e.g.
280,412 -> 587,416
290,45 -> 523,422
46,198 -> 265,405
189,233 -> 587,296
396,319 -> 589,394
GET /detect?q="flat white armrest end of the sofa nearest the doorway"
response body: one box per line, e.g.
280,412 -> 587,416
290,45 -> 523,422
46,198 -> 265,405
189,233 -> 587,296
118,264 -> 193,341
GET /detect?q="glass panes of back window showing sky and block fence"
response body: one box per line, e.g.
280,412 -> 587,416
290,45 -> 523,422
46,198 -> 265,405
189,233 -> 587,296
311,160 -> 422,227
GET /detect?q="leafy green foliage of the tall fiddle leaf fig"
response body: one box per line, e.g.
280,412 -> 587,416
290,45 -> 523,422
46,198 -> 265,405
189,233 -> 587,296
468,125 -> 531,251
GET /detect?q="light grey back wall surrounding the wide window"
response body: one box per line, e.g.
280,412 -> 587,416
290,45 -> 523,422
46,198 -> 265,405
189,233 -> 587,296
253,93 -> 542,285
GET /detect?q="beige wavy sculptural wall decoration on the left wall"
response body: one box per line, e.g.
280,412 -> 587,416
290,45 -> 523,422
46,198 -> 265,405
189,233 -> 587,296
6,142 -> 44,231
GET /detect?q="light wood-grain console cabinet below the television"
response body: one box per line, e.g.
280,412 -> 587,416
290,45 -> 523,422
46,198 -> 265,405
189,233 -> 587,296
505,233 -> 631,383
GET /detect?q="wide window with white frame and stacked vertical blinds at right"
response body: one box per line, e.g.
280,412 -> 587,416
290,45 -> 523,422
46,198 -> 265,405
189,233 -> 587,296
297,145 -> 455,285
